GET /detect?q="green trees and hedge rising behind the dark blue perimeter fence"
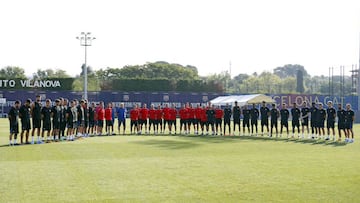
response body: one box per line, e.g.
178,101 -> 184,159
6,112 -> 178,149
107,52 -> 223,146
0,61 -> 355,96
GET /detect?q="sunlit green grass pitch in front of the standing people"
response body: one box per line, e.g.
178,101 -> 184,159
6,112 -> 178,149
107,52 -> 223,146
0,119 -> 360,202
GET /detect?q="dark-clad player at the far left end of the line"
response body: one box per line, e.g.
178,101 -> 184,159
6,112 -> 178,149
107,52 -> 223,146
8,101 -> 21,146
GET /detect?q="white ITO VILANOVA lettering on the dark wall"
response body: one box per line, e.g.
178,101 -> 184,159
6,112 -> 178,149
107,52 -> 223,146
0,80 -> 61,88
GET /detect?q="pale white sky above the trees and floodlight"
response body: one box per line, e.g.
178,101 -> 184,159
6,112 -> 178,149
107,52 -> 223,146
0,0 -> 360,76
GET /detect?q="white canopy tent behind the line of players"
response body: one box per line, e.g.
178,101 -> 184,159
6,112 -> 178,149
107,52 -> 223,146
210,94 -> 275,106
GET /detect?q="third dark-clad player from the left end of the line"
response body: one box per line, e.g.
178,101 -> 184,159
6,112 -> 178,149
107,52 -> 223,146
31,95 -> 42,144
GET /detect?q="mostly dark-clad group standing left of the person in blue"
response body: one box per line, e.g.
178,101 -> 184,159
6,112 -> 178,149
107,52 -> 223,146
8,95 -> 113,145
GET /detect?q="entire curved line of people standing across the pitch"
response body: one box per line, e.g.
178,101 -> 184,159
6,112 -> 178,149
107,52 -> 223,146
9,95 -> 354,146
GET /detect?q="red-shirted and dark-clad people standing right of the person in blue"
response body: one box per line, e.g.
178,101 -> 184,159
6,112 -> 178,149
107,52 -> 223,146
124,101 -> 355,142
